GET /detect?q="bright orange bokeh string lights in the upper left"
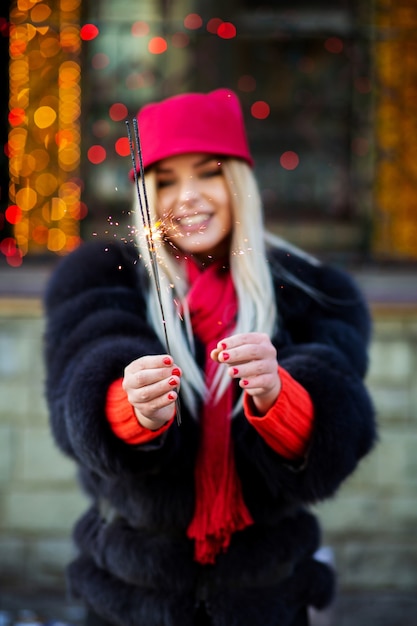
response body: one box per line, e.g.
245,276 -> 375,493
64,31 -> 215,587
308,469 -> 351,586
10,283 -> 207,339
6,0 -> 83,266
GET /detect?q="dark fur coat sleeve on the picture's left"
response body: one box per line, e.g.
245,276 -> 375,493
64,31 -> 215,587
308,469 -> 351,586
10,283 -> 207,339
45,236 -> 185,476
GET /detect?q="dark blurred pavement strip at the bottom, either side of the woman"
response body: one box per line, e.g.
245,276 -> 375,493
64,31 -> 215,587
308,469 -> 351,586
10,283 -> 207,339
0,589 -> 417,626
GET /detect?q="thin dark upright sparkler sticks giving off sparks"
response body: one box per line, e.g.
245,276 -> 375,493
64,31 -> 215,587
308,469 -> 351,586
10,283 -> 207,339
126,118 -> 181,425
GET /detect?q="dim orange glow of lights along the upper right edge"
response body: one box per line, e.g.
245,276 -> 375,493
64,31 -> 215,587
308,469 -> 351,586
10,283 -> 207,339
374,0 -> 417,259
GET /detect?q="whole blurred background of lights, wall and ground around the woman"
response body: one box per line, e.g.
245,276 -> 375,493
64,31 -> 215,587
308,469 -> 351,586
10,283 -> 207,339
0,0 -> 417,626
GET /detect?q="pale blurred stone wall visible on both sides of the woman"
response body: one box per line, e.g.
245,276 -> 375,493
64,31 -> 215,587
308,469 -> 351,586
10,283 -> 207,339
0,297 -> 417,590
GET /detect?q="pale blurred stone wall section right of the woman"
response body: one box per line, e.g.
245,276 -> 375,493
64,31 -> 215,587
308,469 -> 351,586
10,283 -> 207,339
317,306 -> 417,590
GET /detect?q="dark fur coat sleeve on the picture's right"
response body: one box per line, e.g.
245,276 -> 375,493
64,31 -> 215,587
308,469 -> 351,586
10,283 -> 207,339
233,246 -> 376,511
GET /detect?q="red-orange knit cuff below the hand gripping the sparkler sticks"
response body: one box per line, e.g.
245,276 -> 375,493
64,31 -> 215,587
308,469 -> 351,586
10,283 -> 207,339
105,378 -> 174,445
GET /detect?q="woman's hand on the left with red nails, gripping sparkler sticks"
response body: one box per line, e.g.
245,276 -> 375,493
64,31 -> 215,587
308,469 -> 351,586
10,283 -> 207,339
123,354 -> 181,430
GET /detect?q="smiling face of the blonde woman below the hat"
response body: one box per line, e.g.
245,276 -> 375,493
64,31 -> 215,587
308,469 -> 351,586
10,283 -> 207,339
155,153 -> 232,261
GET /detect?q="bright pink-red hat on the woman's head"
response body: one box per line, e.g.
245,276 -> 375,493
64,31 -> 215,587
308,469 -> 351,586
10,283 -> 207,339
130,89 -> 253,178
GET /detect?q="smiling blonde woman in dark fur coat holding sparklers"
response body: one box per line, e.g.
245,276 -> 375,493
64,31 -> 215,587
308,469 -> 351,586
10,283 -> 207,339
45,89 -> 375,626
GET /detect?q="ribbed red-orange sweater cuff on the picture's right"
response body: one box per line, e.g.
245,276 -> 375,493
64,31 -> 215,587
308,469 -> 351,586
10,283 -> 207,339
243,366 -> 314,460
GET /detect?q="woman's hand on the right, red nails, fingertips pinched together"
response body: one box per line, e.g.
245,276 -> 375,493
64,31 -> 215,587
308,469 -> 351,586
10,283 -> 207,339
210,333 -> 281,415
